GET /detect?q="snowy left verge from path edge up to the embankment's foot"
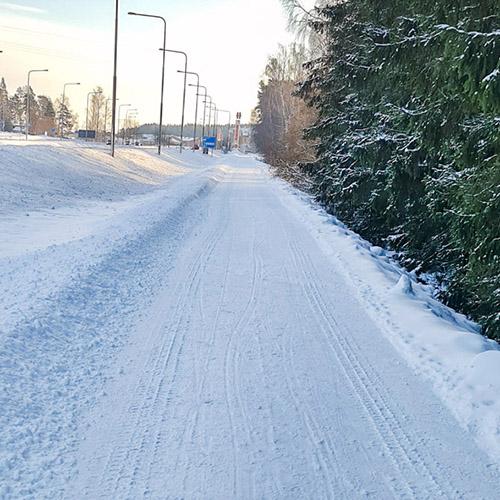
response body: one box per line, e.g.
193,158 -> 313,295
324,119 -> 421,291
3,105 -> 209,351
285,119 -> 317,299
0,162 -> 225,498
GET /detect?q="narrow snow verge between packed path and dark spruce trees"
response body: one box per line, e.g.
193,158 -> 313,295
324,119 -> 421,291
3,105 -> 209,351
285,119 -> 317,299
275,170 -> 500,463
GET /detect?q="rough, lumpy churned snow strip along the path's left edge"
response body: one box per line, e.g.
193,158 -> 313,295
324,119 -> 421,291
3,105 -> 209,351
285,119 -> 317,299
0,183 -> 205,496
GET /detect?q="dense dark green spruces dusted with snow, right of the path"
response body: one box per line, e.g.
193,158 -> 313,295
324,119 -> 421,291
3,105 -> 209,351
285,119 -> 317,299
299,0 -> 500,338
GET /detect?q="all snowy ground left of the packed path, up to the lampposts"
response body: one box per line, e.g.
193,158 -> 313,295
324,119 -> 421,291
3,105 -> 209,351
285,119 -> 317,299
0,141 -> 225,498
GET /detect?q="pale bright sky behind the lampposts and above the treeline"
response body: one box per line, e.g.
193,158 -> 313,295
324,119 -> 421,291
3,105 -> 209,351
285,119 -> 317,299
0,0 -> 308,123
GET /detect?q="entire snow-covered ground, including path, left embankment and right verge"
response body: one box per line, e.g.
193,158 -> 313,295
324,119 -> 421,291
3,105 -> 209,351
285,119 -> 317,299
0,137 -> 500,499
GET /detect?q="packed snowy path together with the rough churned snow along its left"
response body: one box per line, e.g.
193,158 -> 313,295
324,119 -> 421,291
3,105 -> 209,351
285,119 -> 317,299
0,142 -> 500,499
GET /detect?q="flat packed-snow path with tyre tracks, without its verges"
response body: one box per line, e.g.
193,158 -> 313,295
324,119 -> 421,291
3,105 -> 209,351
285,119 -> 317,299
65,160 -> 498,499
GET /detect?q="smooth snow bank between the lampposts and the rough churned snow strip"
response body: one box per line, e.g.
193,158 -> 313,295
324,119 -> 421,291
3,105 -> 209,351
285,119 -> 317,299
0,134 -> 222,330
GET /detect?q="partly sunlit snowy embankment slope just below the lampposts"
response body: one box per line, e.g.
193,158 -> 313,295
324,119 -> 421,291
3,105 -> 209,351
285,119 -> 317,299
0,135 -> 186,215
